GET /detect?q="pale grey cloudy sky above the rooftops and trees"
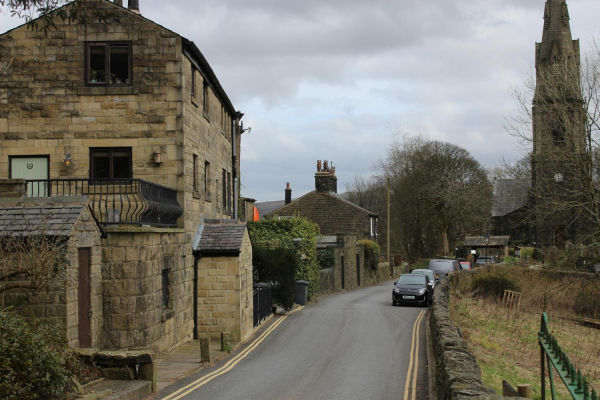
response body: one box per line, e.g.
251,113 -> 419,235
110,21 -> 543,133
0,0 -> 600,202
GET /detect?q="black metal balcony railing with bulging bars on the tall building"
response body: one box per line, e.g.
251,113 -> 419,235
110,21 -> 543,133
27,179 -> 183,226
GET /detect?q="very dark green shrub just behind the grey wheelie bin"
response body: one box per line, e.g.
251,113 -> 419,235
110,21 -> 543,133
252,246 -> 298,310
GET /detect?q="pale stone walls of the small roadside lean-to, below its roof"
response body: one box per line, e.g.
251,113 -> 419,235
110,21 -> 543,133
198,231 -> 253,341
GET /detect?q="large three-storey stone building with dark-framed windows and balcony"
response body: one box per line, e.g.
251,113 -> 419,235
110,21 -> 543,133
0,0 -> 252,352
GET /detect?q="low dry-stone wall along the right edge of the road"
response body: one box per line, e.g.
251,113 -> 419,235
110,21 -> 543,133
429,278 -> 504,400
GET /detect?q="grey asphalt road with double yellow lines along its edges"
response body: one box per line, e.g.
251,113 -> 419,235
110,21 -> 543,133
157,281 -> 428,400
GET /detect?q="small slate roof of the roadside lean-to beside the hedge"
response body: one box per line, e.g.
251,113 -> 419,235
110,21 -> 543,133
194,219 -> 246,253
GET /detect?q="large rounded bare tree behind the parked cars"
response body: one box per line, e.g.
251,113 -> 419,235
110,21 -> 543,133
377,136 -> 492,259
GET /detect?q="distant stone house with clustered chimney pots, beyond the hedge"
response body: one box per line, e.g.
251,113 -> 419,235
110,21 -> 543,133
265,160 -> 378,241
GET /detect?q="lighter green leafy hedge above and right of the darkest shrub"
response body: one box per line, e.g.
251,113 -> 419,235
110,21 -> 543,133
248,218 -> 319,299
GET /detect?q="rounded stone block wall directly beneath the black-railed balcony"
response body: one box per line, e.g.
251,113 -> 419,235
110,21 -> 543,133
102,227 -> 193,353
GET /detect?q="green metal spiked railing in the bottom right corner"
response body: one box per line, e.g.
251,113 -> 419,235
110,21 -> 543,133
538,313 -> 598,400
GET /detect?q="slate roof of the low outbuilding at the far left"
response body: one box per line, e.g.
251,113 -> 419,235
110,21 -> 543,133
0,199 -> 86,236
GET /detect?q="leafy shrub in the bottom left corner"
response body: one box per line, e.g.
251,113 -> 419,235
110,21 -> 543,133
0,310 -> 81,400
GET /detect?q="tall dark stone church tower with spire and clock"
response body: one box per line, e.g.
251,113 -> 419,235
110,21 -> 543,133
530,0 -> 586,248
